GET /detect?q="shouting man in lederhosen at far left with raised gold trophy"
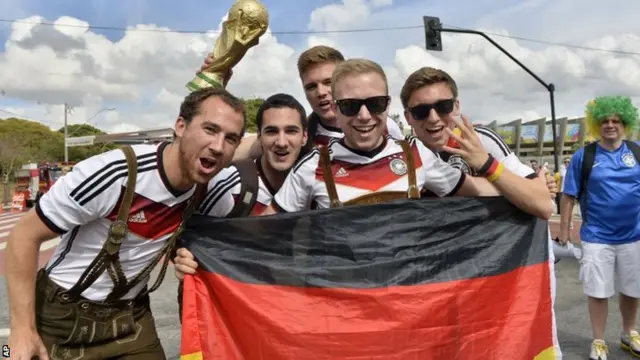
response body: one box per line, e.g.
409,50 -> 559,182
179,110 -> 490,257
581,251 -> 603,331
6,0 -> 268,360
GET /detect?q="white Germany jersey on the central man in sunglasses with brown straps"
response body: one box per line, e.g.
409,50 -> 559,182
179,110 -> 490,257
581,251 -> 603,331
273,138 -> 464,212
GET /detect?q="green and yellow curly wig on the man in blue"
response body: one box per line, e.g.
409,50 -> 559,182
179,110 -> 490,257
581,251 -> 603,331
585,96 -> 638,138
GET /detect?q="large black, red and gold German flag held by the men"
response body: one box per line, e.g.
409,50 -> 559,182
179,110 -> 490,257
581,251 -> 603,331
181,198 -> 558,360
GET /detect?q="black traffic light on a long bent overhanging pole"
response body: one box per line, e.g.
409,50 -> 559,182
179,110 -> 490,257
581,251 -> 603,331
423,16 -> 560,214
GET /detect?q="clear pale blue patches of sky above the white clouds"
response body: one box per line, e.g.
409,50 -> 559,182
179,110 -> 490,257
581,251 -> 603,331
0,0 -> 517,51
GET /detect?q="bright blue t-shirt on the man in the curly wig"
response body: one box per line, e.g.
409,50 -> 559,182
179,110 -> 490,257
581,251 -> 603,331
563,142 -> 640,245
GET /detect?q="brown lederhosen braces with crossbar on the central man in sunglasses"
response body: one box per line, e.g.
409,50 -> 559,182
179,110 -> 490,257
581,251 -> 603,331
320,140 -> 420,207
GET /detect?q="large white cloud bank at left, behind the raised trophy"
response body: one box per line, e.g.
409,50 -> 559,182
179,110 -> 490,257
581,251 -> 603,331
0,13 -> 301,131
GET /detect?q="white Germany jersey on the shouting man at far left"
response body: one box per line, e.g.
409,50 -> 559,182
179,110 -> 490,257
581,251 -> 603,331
36,143 -> 195,301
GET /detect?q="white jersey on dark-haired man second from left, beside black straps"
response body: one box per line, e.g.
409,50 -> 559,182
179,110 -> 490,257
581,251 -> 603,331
199,158 -> 275,217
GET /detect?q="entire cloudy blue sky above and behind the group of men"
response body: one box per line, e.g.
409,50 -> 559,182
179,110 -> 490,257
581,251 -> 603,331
0,0 -> 640,126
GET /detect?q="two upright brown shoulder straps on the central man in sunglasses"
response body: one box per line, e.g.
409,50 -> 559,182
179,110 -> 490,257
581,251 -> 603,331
320,140 -> 420,207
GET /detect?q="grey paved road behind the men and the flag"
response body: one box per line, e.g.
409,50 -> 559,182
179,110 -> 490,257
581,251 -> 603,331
0,215 -> 633,360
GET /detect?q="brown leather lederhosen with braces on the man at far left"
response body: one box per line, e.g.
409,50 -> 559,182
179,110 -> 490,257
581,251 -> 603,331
36,146 -> 206,360
